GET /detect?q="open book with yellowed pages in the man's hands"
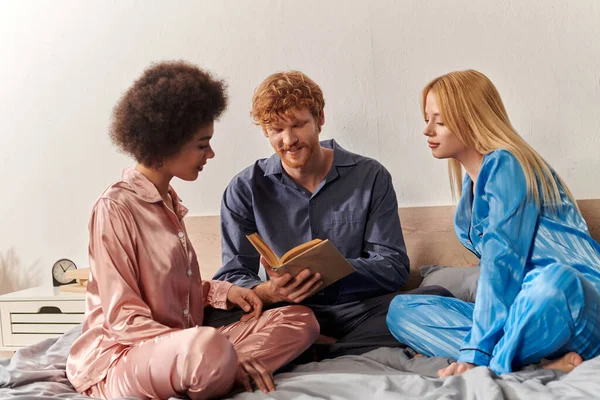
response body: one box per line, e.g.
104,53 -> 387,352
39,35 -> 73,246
246,233 -> 355,287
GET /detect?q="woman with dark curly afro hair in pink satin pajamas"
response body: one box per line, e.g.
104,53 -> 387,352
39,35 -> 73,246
67,62 -> 319,398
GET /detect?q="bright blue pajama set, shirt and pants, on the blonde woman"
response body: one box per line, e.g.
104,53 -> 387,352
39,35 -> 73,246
387,150 -> 600,374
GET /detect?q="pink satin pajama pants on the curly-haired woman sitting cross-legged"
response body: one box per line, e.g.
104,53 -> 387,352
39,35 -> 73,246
86,306 -> 319,399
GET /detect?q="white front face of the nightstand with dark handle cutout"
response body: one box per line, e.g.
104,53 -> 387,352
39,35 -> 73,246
0,300 -> 85,347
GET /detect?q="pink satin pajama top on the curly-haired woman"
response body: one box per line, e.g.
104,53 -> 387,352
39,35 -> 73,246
67,169 -> 232,392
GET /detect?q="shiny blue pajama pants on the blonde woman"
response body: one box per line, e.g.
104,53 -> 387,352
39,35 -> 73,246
387,264 -> 600,374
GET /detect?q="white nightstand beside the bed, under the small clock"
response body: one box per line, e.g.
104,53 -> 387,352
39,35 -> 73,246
0,286 -> 85,352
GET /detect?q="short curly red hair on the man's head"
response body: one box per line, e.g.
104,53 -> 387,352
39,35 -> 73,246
251,71 -> 325,129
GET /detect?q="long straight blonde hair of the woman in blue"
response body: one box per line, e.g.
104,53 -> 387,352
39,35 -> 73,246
422,70 -> 577,210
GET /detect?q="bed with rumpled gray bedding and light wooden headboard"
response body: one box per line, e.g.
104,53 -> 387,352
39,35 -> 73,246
0,203 -> 600,400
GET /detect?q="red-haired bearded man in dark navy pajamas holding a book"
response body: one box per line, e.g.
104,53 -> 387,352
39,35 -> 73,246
215,71 -> 448,358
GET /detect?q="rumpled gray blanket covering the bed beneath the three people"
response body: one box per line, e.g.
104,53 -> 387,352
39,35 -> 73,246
0,328 -> 600,400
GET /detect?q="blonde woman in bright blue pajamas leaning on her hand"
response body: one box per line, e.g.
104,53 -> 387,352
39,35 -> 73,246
387,70 -> 600,376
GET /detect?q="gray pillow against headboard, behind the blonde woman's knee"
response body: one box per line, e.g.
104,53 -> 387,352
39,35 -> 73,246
419,265 -> 479,303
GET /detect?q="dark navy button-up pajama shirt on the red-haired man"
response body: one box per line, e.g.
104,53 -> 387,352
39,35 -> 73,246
213,139 -> 409,304
